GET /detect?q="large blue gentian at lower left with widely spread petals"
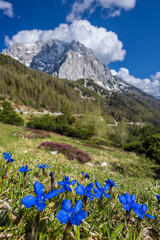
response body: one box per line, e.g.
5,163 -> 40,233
21,181 -> 59,211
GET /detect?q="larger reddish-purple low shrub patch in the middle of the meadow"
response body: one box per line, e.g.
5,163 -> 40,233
38,142 -> 91,163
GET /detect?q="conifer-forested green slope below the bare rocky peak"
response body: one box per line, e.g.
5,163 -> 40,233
0,54 -> 160,125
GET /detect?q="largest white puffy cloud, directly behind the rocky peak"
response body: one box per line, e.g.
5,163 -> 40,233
5,20 -> 125,65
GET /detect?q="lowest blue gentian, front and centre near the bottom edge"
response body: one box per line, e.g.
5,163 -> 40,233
57,199 -> 87,226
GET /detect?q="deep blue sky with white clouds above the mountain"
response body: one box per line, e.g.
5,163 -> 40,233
0,0 -> 160,97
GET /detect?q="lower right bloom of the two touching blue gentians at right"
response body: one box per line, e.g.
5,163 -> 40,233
132,203 -> 155,219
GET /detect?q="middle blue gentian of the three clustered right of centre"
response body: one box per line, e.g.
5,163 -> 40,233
91,181 -> 112,199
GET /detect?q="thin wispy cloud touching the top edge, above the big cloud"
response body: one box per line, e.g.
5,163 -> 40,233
66,0 -> 136,22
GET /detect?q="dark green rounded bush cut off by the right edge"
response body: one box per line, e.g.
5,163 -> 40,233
142,135 -> 160,163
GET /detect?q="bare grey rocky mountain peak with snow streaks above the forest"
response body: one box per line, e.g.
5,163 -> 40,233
3,39 -> 128,92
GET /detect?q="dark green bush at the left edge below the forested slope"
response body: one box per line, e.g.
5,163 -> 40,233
0,101 -> 24,126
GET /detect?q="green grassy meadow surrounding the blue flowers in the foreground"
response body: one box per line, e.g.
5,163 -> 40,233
0,123 -> 160,240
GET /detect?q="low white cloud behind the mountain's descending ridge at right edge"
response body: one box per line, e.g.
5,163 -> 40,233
111,68 -> 160,98
